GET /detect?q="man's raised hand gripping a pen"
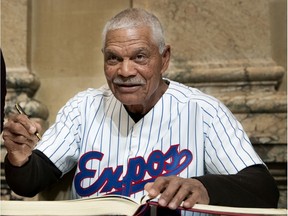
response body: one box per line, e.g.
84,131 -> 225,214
3,114 -> 41,167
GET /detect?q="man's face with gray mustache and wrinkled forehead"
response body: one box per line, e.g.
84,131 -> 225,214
103,27 -> 170,112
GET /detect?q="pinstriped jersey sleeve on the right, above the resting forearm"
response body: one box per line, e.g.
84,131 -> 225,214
205,101 -> 263,174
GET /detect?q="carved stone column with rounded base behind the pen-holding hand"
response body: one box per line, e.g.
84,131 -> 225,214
1,0 -> 48,199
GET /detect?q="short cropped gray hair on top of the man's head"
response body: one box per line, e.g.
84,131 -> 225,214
102,8 -> 165,53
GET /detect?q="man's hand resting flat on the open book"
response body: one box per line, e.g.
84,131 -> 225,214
145,176 -> 209,209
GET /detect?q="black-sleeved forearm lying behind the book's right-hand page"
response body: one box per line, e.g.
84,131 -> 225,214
195,165 -> 279,208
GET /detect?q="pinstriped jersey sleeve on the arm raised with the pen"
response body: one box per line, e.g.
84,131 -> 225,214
36,95 -> 85,175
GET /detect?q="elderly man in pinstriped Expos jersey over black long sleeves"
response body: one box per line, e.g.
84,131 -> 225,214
3,8 -> 279,213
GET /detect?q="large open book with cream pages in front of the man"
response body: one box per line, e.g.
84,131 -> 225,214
0,195 -> 287,216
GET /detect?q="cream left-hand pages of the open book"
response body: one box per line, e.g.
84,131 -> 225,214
1,196 -> 139,216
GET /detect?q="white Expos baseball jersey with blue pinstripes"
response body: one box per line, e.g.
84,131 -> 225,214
37,80 -> 263,207
